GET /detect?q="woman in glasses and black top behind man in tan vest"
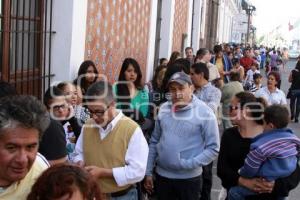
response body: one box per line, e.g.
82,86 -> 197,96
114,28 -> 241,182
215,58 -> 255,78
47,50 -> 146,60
39,86 -> 81,165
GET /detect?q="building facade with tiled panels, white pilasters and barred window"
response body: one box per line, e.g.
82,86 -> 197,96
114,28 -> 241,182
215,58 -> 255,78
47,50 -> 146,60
0,0 -> 248,96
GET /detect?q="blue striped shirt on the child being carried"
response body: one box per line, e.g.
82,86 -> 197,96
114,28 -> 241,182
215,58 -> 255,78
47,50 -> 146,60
239,129 -> 300,181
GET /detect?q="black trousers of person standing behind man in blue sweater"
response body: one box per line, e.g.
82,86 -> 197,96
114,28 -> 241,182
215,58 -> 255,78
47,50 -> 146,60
200,162 -> 213,200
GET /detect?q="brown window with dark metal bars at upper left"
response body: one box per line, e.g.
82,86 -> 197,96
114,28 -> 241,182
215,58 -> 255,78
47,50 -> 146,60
0,0 -> 54,98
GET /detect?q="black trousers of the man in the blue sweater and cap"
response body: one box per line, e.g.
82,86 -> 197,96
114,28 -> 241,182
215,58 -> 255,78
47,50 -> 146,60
156,175 -> 202,200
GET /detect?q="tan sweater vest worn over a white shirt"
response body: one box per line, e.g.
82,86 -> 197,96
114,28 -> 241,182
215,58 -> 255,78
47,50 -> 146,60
83,116 -> 138,193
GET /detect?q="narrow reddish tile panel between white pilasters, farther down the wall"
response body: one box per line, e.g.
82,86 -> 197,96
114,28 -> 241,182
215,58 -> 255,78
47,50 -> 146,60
172,0 -> 188,52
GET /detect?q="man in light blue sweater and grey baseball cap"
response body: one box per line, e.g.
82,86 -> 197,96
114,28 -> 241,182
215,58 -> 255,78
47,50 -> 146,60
144,72 -> 220,200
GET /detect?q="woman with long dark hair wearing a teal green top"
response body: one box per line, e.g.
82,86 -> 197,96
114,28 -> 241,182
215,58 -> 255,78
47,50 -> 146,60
115,58 -> 149,117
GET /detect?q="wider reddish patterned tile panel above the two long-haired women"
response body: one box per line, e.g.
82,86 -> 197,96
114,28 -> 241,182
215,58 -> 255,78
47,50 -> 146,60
85,0 -> 151,83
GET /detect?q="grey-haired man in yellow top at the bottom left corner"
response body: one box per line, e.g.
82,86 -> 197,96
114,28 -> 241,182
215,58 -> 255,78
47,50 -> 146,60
0,96 -> 50,200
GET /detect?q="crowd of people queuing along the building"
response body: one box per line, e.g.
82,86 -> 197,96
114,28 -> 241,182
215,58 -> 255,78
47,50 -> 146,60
0,44 -> 300,200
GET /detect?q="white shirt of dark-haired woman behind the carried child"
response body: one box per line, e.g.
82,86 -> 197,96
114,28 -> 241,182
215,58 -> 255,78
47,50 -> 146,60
255,86 -> 287,105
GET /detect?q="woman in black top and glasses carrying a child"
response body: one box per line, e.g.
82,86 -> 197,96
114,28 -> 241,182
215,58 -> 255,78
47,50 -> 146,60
217,92 -> 300,200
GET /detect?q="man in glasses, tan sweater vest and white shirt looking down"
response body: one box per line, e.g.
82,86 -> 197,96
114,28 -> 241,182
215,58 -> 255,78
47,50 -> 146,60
74,81 -> 148,200
